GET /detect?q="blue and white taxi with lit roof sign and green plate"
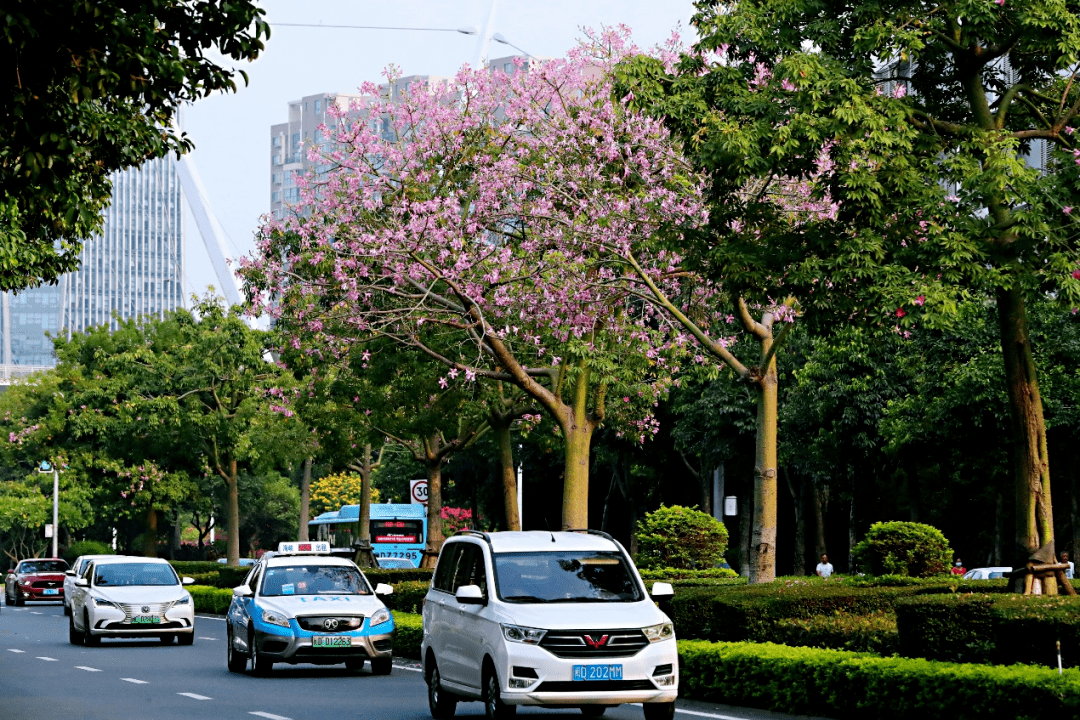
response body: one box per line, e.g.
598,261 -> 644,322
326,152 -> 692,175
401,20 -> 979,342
226,542 -> 394,675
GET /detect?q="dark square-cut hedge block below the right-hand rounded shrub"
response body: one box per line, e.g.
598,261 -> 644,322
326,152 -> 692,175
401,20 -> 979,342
893,595 -> 994,663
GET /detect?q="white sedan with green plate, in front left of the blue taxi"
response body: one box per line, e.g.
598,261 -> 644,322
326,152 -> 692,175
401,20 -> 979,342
68,555 -> 195,646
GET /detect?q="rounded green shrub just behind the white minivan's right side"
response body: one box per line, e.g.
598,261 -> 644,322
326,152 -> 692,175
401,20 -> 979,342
634,505 -> 728,569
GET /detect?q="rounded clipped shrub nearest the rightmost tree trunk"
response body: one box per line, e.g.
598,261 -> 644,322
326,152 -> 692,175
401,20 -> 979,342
854,521 -> 953,578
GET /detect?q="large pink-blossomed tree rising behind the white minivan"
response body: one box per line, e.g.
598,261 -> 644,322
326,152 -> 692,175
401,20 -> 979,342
242,32 -> 704,527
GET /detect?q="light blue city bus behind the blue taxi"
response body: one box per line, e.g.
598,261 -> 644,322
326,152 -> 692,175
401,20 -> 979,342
308,503 -> 428,568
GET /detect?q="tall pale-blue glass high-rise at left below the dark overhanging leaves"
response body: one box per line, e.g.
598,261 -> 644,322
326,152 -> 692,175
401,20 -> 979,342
0,158 -> 184,375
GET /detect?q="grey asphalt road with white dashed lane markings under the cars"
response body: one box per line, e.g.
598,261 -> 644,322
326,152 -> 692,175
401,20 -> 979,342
0,603 -> 829,720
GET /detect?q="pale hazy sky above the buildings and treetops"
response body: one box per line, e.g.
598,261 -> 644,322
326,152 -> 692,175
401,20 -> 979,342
183,0 -> 693,296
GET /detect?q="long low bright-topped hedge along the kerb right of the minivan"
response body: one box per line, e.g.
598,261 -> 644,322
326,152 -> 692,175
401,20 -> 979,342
678,640 -> 1080,720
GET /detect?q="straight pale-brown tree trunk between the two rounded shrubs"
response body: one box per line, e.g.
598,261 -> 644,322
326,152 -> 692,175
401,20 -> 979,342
750,354 -> 778,584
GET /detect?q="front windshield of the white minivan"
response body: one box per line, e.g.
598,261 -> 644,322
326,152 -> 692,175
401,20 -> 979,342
494,552 -> 644,602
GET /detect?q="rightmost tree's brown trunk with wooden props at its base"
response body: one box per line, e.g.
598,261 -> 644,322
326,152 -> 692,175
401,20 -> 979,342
997,289 -> 1057,595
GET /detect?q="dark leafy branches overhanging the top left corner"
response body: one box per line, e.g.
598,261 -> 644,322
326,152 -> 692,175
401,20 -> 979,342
0,0 -> 270,290
